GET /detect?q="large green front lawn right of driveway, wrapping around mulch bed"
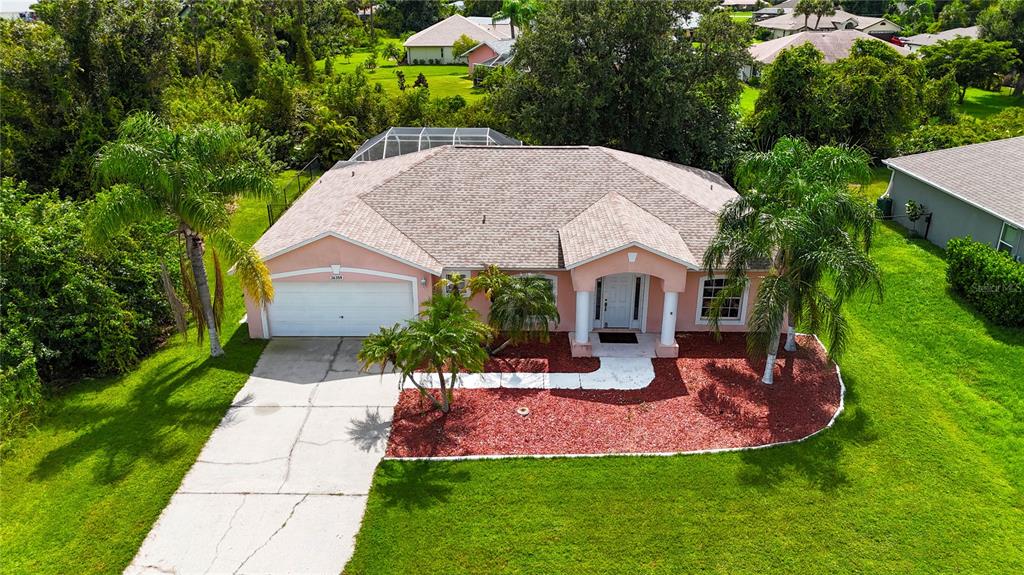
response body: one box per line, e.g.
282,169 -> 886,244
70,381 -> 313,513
347,177 -> 1024,574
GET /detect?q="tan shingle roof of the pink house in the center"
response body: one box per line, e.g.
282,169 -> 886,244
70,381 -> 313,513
255,145 -> 737,268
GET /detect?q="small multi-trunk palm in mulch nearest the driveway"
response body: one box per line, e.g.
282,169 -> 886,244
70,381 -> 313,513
357,292 -> 490,413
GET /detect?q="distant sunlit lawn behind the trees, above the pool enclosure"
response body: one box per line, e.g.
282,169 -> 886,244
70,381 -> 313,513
316,40 -> 484,102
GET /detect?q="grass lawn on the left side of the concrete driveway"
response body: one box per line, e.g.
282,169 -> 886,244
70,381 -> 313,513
0,172 -> 309,574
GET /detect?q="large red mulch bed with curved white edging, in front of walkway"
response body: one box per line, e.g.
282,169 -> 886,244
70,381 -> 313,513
387,334 -> 840,457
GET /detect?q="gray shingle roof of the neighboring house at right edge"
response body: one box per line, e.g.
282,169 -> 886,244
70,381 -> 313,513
885,136 -> 1024,227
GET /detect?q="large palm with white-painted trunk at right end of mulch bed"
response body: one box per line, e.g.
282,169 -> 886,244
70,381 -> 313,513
703,138 -> 882,384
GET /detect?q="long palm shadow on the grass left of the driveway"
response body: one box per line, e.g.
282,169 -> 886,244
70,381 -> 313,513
30,329 -> 262,484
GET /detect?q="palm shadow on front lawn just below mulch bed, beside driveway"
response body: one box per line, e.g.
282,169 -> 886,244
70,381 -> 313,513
373,460 -> 470,510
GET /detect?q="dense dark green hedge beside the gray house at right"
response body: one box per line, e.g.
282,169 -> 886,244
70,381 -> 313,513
946,237 -> 1024,326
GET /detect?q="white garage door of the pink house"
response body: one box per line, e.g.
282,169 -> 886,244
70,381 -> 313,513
268,280 -> 415,337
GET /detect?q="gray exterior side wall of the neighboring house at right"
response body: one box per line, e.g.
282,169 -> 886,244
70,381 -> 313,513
886,171 -> 1024,257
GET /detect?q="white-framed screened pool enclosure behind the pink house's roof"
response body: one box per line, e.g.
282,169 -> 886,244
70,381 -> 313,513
348,126 -> 522,162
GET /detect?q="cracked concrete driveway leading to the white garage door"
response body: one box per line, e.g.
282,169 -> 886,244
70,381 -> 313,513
125,338 -> 398,575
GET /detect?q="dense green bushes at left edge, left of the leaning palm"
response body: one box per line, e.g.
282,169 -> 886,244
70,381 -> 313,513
0,178 -> 175,427
